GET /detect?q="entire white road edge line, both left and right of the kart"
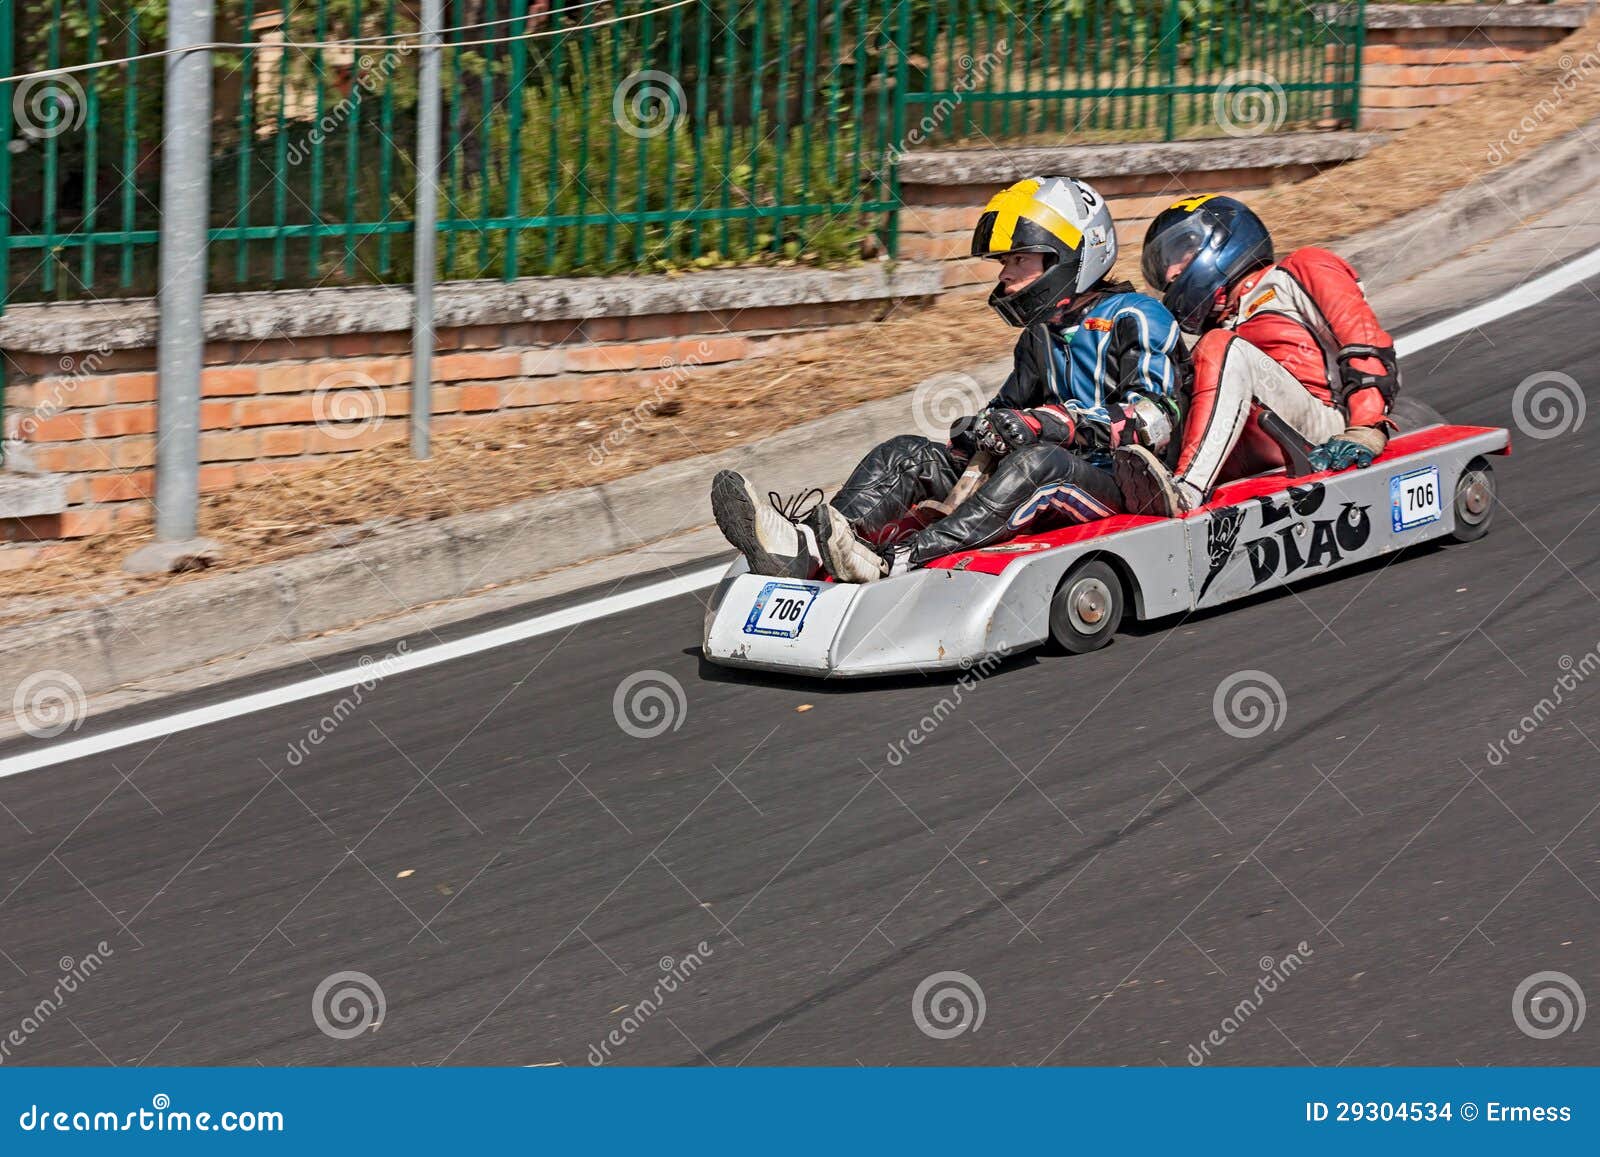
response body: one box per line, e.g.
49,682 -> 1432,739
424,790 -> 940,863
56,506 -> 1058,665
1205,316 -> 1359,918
9,241 -> 1600,779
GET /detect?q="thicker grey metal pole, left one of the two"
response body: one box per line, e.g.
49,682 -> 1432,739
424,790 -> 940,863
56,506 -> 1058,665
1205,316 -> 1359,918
155,0 -> 213,542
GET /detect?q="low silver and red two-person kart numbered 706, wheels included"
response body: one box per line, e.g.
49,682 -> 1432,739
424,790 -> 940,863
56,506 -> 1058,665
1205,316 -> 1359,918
704,398 -> 1510,677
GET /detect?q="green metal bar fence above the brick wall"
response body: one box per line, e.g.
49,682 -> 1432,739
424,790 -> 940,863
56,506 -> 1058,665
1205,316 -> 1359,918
0,0 -> 1362,306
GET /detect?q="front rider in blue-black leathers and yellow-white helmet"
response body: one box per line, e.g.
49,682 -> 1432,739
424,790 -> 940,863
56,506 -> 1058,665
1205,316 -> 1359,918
710,176 -> 1189,583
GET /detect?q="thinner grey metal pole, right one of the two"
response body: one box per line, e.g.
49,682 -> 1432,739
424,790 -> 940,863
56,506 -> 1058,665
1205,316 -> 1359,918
411,0 -> 445,458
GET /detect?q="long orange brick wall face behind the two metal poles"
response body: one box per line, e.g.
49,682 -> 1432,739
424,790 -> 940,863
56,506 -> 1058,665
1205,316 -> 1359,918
0,291 -> 938,570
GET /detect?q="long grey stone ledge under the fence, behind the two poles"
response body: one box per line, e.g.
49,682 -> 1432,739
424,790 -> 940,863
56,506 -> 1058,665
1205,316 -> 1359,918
0,261 -> 942,354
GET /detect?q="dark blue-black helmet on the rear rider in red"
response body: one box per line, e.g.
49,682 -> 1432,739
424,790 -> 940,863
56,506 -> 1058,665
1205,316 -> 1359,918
1139,194 -> 1272,333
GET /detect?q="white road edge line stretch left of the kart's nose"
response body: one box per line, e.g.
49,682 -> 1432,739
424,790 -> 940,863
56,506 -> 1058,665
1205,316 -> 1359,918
0,565 -> 728,779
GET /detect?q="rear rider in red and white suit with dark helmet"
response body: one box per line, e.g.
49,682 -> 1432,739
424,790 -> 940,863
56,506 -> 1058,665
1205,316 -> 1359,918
1115,194 -> 1400,515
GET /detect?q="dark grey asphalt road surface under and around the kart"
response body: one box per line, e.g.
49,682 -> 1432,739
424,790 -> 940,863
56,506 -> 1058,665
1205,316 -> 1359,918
0,278 -> 1600,1066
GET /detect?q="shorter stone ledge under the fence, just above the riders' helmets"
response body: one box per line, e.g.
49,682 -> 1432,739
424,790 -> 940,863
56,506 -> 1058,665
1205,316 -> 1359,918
901,131 -> 1387,186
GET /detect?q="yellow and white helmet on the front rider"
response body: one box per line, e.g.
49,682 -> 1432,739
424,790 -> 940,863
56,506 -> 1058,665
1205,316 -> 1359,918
973,176 -> 1117,326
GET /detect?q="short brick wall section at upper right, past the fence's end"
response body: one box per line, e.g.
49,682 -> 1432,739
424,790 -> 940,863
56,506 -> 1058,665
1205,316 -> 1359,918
1362,3 -> 1589,130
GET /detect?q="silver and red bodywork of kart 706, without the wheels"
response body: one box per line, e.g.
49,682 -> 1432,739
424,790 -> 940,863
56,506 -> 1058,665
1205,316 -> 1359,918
704,427 -> 1509,677
